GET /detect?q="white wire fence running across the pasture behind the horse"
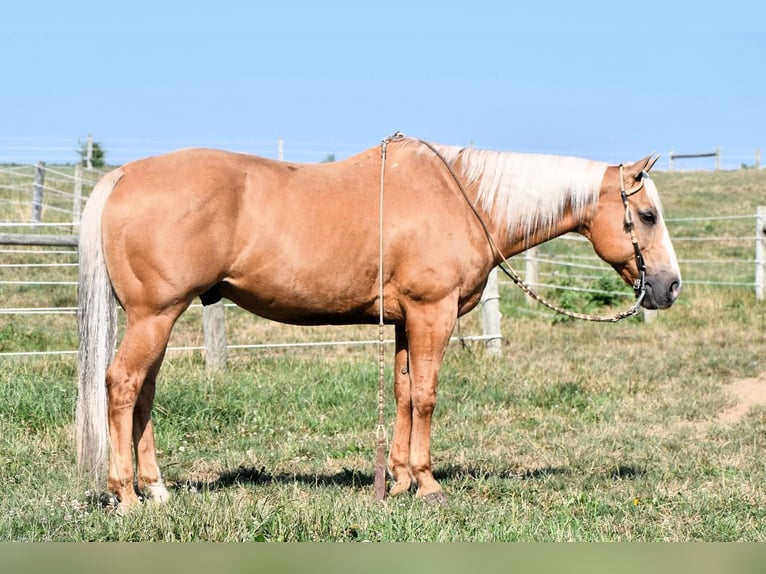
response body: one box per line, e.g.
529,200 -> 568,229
0,160 -> 766,357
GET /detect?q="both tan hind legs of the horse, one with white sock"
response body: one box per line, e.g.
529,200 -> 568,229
106,311 -> 180,507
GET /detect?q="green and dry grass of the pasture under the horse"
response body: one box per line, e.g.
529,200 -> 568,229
0,163 -> 766,541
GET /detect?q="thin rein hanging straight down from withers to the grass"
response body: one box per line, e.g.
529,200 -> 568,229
375,132 -> 402,502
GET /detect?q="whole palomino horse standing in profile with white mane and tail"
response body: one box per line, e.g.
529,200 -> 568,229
77,135 -> 681,507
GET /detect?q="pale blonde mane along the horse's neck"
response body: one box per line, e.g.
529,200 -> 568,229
412,144 -> 607,242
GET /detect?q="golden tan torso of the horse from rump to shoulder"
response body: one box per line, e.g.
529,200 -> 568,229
96,143 -> 487,323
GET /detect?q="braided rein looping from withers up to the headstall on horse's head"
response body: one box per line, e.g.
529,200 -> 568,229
418,140 -> 646,323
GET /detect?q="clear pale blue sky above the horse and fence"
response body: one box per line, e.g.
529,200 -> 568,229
0,0 -> 766,167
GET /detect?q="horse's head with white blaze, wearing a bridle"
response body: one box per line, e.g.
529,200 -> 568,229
588,156 -> 681,309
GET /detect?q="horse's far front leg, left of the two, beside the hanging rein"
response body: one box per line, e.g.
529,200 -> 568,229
388,325 -> 412,496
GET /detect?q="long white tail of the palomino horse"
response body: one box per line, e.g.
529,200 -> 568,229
76,169 -> 122,479
